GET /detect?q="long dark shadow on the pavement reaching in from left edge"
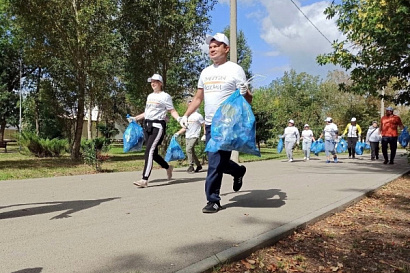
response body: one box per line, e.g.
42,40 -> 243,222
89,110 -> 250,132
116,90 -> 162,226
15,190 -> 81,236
0,197 -> 119,220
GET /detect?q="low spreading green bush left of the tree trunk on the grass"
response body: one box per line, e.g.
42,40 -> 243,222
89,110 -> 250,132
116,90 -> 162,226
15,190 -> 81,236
19,131 -> 68,157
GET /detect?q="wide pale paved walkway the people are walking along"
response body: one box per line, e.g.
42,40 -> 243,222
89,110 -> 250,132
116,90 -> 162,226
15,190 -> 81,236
0,150 -> 409,273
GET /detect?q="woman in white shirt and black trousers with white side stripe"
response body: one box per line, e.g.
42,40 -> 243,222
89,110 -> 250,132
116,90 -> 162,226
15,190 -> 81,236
130,74 -> 180,188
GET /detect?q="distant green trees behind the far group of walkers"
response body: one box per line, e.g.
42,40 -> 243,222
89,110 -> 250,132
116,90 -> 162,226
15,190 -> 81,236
252,70 -> 379,141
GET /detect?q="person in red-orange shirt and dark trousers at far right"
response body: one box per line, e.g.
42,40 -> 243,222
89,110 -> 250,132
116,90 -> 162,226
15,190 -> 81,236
380,106 -> 403,164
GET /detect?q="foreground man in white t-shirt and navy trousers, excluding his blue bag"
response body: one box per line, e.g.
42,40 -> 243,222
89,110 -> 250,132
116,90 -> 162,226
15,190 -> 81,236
180,33 -> 252,213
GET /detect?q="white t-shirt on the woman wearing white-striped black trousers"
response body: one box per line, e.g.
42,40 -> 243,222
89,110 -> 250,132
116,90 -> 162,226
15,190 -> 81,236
144,91 -> 174,120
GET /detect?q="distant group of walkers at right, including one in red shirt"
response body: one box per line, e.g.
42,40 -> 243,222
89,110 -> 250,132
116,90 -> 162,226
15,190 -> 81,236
281,107 -> 404,164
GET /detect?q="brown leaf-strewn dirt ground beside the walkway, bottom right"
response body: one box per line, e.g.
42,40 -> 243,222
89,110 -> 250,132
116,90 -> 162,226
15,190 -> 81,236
213,175 -> 410,273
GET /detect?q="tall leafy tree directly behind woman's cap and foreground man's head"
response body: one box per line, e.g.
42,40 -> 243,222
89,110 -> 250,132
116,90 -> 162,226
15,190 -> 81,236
119,0 -> 217,110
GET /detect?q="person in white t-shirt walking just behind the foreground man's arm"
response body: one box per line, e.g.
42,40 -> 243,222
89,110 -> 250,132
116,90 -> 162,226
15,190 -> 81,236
175,100 -> 205,173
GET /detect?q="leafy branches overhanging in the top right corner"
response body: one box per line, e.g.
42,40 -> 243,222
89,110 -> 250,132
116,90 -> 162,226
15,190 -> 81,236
317,0 -> 410,104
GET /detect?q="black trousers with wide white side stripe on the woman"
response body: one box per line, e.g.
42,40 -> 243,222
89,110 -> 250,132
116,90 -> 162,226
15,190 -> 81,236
142,123 -> 169,180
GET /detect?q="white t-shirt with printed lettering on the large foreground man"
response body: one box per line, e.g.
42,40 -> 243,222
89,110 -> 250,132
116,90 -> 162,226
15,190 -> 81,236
198,61 -> 246,125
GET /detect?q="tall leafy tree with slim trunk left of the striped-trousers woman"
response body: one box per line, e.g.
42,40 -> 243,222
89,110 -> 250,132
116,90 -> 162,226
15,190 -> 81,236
10,0 -> 121,159
